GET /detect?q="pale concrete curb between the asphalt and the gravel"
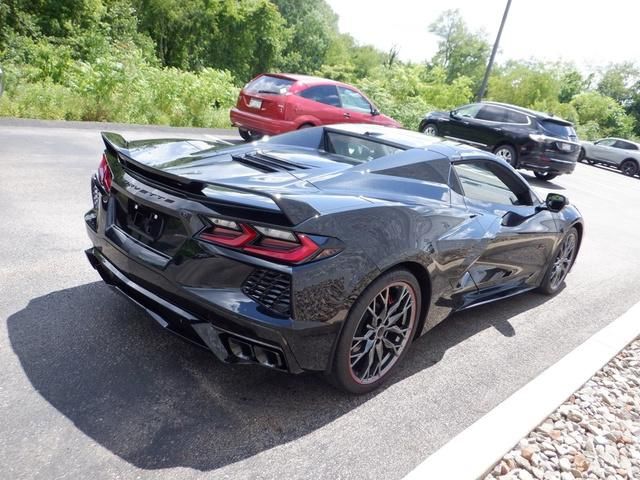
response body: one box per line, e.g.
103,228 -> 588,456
404,303 -> 640,480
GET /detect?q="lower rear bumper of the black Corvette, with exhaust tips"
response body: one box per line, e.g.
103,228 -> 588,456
85,211 -> 338,373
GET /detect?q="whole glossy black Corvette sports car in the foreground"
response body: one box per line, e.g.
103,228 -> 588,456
85,124 -> 583,393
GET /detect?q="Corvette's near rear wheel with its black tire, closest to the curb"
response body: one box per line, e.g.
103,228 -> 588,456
329,269 -> 421,395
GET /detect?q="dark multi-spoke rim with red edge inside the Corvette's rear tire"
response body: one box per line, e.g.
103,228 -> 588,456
349,282 -> 417,384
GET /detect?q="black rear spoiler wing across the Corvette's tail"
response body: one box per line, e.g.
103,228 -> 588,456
101,132 -> 319,226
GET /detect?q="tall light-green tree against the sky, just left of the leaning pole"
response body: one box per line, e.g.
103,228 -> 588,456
429,9 -> 491,83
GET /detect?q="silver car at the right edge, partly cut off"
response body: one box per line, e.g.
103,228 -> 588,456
578,138 -> 640,177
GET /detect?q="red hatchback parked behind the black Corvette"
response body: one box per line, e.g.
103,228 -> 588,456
230,73 -> 401,140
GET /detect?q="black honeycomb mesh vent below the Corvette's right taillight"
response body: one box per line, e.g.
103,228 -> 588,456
242,268 -> 291,317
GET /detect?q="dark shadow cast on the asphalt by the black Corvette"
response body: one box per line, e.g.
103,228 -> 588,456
8,282 -> 548,471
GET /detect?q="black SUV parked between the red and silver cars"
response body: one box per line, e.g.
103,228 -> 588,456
419,102 -> 580,180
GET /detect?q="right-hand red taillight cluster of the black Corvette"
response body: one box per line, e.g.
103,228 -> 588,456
198,218 -> 324,263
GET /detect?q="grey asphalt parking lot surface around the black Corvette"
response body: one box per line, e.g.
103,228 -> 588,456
0,120 -> 640,479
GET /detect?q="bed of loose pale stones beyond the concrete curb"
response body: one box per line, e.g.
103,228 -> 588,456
484,339 -> 640,480
